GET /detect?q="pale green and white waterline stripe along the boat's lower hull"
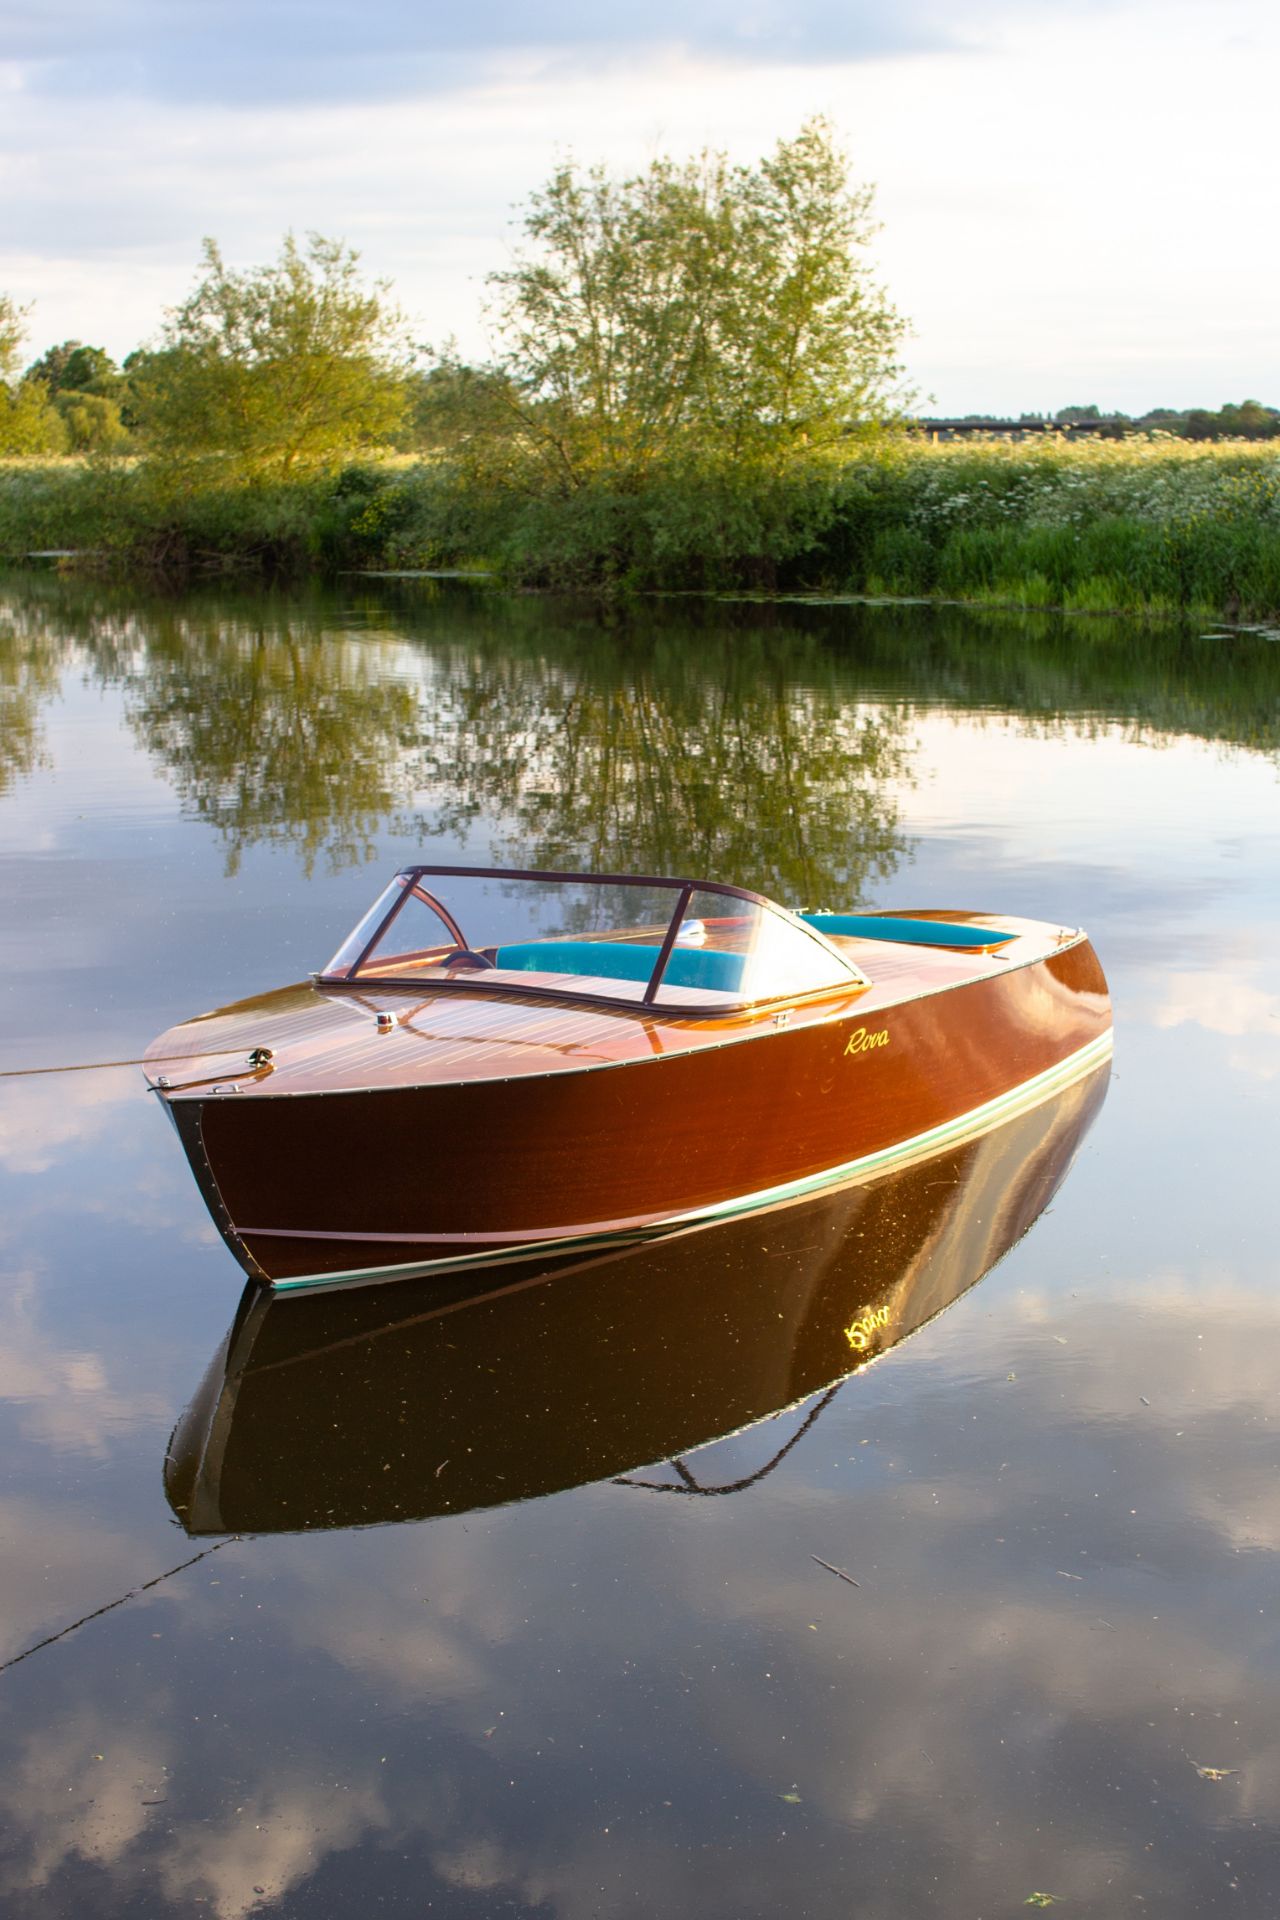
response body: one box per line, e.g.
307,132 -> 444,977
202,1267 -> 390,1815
271,1031 -> 1113,1294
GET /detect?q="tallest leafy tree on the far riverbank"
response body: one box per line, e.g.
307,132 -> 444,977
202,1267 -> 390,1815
474,119 -> 904,488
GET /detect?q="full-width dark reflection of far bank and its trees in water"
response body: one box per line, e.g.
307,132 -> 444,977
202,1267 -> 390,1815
0,576 -> 1280,904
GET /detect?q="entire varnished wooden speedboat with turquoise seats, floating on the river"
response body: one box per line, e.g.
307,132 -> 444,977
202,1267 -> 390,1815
146,866 -> 1111,1290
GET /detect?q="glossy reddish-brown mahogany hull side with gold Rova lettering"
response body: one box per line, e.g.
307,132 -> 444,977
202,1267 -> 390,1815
171,939 -> 1111,1286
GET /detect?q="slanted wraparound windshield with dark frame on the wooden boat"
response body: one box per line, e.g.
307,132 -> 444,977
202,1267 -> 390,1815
320,866 -> 865,1012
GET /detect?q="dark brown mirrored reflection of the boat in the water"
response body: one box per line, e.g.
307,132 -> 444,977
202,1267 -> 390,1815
165,1064 -> 1109,1534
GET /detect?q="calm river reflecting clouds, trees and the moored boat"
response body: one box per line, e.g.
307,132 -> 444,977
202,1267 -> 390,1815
0,576 -> 1280,1920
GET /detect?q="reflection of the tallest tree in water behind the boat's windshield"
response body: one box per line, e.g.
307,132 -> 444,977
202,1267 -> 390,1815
404,609 -> 910,902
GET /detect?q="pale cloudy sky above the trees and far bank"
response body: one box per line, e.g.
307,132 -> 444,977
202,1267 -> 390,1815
0,0 -> 1280,413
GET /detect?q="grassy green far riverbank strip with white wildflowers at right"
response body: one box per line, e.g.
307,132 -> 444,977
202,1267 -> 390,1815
0,436 -> 1280,620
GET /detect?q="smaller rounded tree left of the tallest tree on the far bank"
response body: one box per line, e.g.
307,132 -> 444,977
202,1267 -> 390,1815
127,234 -> 407,478
